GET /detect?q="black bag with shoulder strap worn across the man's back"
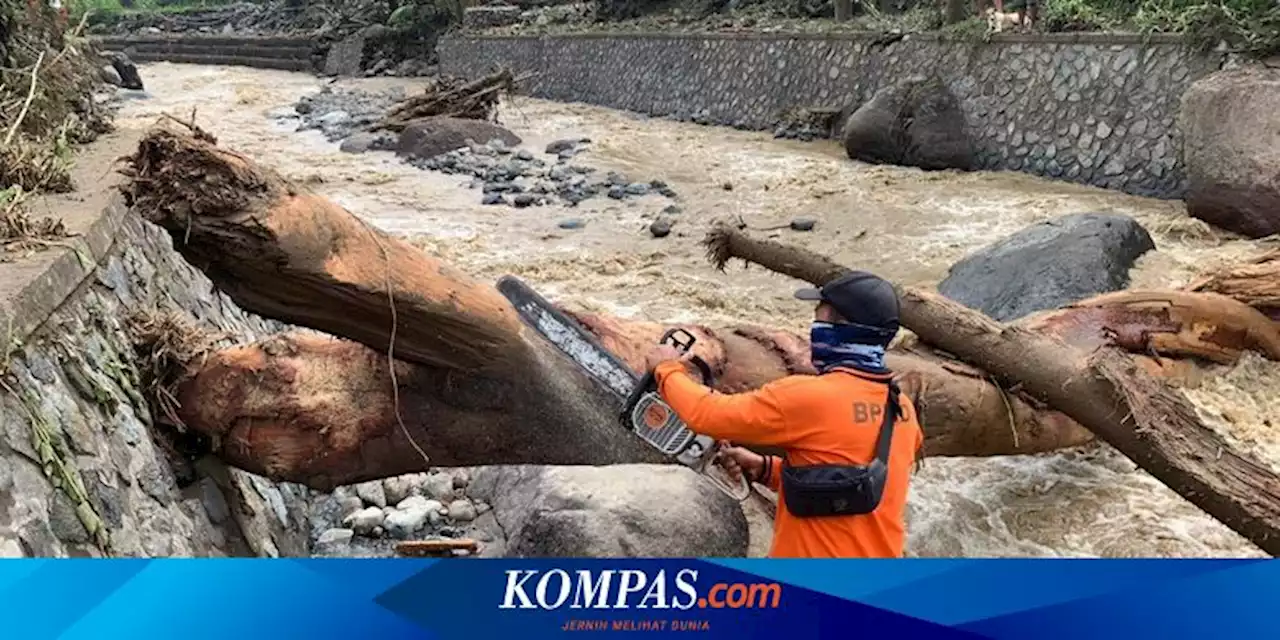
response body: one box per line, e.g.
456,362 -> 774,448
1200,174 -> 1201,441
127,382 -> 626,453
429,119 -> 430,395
782,381 -> 901,517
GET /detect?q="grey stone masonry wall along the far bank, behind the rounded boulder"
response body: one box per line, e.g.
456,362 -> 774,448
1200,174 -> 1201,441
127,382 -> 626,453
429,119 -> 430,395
439,33 -> 1224,197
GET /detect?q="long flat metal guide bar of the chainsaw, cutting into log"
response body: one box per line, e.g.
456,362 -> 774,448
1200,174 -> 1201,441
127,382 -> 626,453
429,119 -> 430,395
498,275 -> 640,408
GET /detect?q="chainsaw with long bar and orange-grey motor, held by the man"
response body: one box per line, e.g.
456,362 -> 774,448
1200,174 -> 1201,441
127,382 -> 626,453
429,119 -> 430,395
498,275 -> 751,502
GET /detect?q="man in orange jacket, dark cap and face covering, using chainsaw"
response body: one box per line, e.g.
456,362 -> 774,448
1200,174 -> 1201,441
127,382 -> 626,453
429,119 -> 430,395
649,271 -> 924,558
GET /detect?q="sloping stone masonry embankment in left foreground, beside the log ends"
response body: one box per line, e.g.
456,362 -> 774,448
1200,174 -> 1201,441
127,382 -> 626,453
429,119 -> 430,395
0,205 -> 310,557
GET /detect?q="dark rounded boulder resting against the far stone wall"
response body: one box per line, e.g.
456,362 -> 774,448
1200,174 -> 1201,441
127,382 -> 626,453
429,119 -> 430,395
842,77 -> 974,170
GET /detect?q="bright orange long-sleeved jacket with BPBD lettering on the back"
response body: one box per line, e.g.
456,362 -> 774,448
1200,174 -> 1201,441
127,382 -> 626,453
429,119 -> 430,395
654,361 -> 924,558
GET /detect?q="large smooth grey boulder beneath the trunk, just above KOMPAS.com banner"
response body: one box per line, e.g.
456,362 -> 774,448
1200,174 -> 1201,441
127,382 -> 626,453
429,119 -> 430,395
471,465 -> 749,558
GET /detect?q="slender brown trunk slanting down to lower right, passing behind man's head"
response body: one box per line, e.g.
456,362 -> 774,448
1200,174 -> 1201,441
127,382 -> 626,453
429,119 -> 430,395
707,227 -> 1280,556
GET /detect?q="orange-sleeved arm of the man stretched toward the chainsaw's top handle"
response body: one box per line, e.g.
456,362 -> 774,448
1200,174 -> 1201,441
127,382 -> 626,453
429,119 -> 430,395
654,360 -> 797,445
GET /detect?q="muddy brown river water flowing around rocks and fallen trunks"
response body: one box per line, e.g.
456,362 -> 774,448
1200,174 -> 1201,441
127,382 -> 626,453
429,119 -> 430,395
118,64 -> 1280,557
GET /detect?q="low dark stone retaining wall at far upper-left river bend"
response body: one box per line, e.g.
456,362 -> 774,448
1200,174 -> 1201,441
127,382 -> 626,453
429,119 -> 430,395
93,36 -> 324,72
